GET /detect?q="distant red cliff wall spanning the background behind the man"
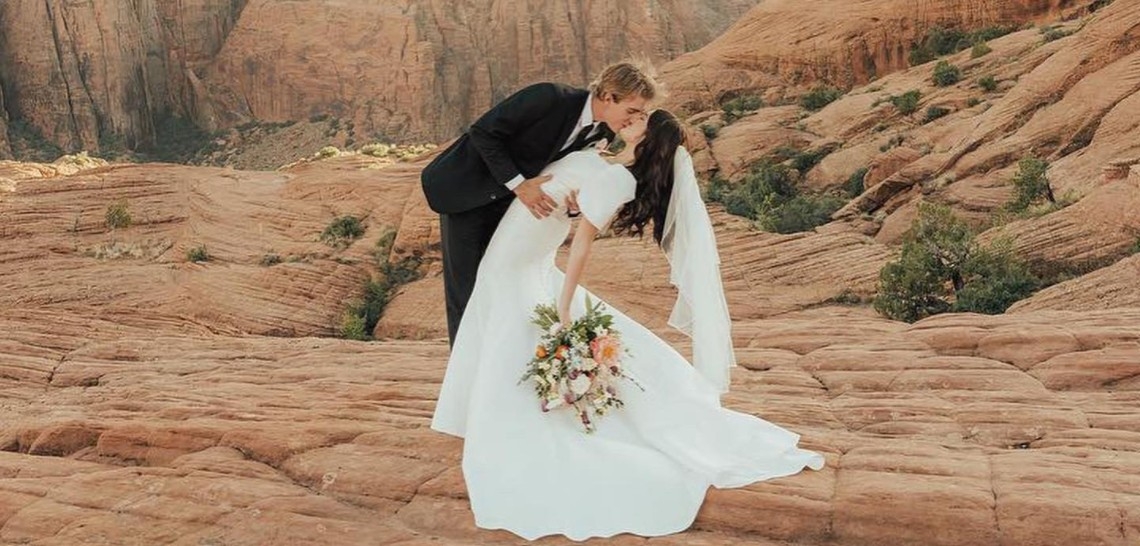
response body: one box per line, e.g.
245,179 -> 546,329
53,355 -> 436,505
0,0 -> 756,150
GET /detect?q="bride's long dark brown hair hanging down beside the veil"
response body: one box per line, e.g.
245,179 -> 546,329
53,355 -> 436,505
612,109 -> 685,245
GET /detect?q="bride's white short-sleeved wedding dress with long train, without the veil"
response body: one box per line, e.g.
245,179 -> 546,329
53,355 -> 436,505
432,152 -> 823,540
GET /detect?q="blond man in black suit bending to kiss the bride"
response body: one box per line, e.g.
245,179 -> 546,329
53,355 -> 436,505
421,63 -> 657,344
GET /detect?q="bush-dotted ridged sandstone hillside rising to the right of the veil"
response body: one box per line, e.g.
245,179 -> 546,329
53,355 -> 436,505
694,2 -> 1140,288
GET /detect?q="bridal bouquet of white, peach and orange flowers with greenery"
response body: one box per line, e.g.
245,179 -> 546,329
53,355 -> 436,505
519,298 -> 641,433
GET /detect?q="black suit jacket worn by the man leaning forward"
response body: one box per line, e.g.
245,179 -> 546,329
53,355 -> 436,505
420,83 -> 613,214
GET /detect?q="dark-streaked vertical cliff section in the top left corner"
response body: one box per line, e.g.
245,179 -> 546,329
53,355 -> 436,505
0,0 -> 245,150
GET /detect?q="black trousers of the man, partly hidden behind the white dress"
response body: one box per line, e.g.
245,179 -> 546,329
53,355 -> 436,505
439,195 -> 514,345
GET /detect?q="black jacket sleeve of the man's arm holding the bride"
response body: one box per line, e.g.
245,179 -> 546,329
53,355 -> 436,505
469,83 -> 559,185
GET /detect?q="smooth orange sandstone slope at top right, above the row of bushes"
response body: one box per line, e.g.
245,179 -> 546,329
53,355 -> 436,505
662,0 -> 1090,112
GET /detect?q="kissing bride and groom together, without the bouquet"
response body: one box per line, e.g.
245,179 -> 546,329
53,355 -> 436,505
422,62 -> 823,540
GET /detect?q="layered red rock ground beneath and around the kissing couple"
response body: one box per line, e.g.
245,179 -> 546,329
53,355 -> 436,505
0,150 -> 1140,546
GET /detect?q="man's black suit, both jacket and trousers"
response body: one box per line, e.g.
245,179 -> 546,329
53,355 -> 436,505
421,83 -> 613,343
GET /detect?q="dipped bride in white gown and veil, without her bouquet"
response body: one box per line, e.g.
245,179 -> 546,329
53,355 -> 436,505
432,109 -> 823,540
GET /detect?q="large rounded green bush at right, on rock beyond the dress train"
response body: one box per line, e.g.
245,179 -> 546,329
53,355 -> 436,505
874,204 -> 1041,323
